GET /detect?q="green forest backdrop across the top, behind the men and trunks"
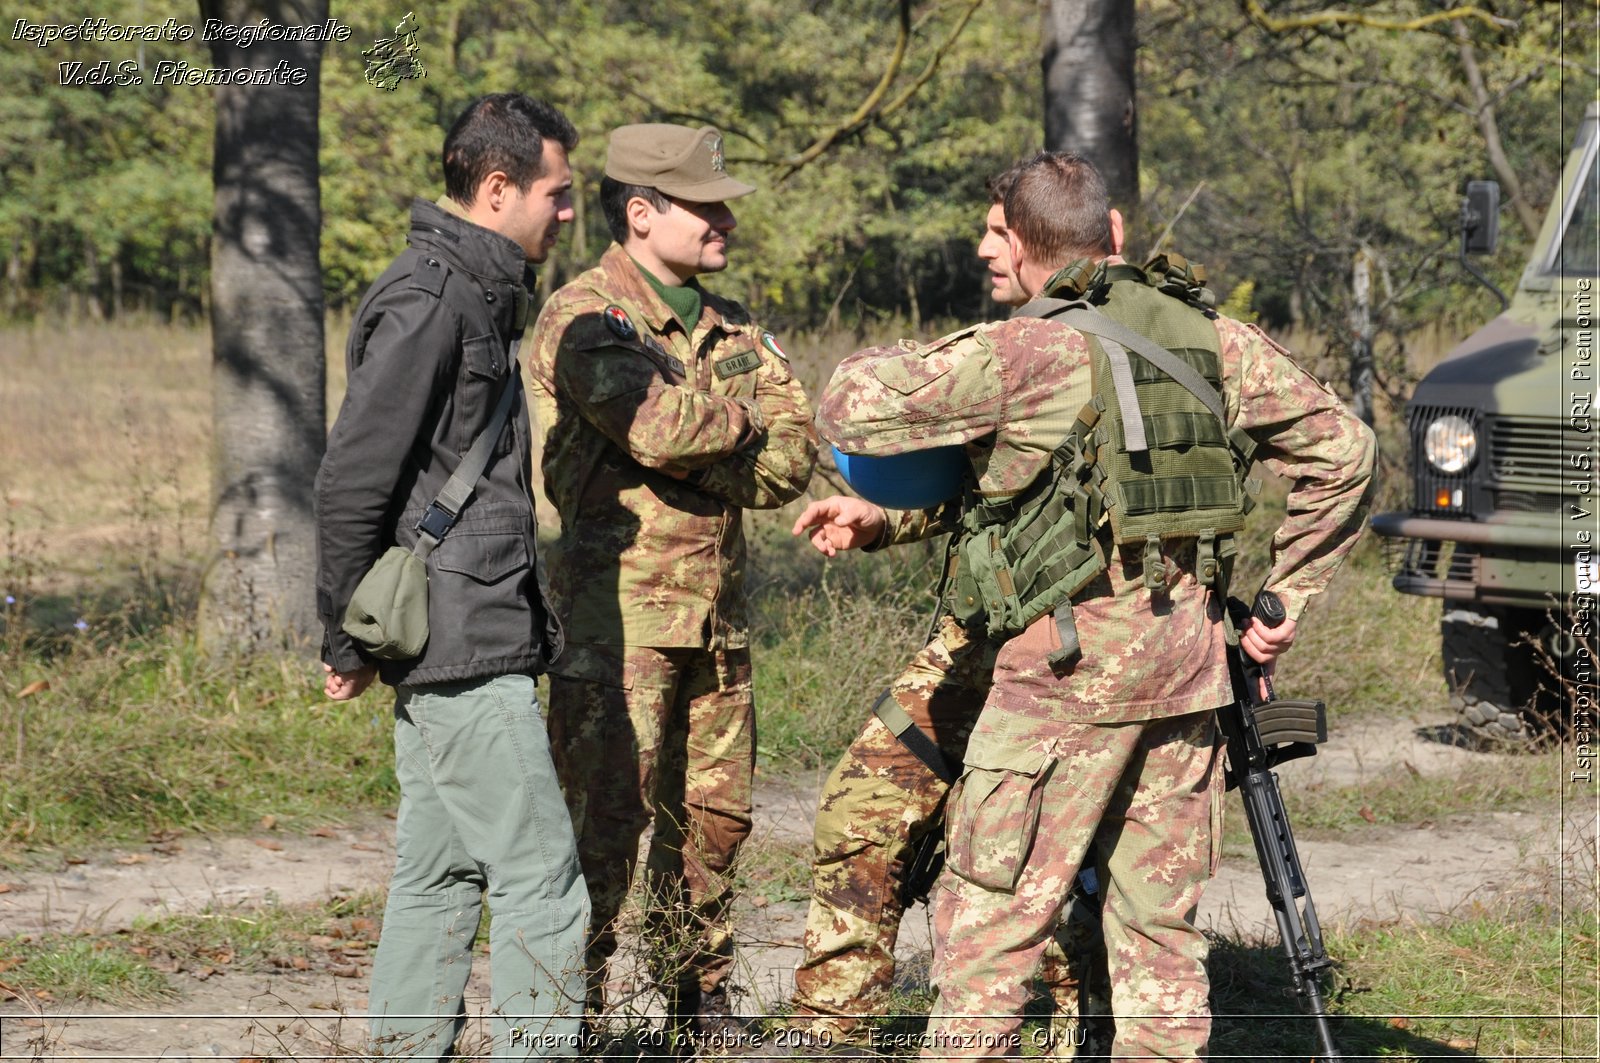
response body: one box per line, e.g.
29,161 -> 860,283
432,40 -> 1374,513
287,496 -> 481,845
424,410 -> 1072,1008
0,0 -> 1597,357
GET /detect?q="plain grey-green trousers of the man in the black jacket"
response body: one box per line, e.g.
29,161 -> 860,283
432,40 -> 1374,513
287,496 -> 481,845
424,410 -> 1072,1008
368,676 -> 589,1060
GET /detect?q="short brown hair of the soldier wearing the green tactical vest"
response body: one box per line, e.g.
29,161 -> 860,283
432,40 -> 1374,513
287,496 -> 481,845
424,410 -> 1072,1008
1005,152 -> 1115,269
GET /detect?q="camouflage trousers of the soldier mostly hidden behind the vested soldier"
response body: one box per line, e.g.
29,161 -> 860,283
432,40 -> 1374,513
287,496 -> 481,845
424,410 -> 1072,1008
794,618 -> 1098,1036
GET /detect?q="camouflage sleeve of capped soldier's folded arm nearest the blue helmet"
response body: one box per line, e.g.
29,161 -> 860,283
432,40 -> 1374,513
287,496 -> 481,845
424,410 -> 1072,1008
691,337 -> 816,509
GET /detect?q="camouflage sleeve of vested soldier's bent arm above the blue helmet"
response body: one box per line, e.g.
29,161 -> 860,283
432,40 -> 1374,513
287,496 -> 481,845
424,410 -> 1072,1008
818,328 -> 1005,455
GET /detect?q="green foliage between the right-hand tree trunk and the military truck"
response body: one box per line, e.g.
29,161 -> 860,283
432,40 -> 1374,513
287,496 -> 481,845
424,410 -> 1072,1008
1131,0 -> 1597,399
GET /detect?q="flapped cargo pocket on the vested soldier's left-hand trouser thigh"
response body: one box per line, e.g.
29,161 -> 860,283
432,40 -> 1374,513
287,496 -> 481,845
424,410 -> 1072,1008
946,736 -> 1056,893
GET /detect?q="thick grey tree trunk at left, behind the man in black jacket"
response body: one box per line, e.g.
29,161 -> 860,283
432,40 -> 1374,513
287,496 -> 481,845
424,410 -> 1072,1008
200,0 -> 328,650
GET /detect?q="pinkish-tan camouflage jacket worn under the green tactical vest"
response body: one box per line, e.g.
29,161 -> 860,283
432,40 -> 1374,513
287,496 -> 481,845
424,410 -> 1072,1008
818,294 -> 1376,725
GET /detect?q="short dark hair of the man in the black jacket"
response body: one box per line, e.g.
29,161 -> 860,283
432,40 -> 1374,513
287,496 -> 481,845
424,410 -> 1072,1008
445,93 -> 578,207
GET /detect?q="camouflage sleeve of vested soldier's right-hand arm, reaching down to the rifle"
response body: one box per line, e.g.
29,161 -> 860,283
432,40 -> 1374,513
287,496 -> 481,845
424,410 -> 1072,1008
1218,319 -> 1378,620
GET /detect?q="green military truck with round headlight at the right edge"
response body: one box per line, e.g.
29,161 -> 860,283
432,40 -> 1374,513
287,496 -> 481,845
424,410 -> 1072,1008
1373,102 -> 1600,741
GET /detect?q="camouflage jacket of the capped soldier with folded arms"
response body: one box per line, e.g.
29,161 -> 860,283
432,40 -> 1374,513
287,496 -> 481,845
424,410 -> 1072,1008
528,245 -> 816,653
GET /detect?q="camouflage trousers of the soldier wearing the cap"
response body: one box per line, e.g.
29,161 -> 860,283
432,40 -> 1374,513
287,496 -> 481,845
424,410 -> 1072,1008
550,645 -> 755,1007
